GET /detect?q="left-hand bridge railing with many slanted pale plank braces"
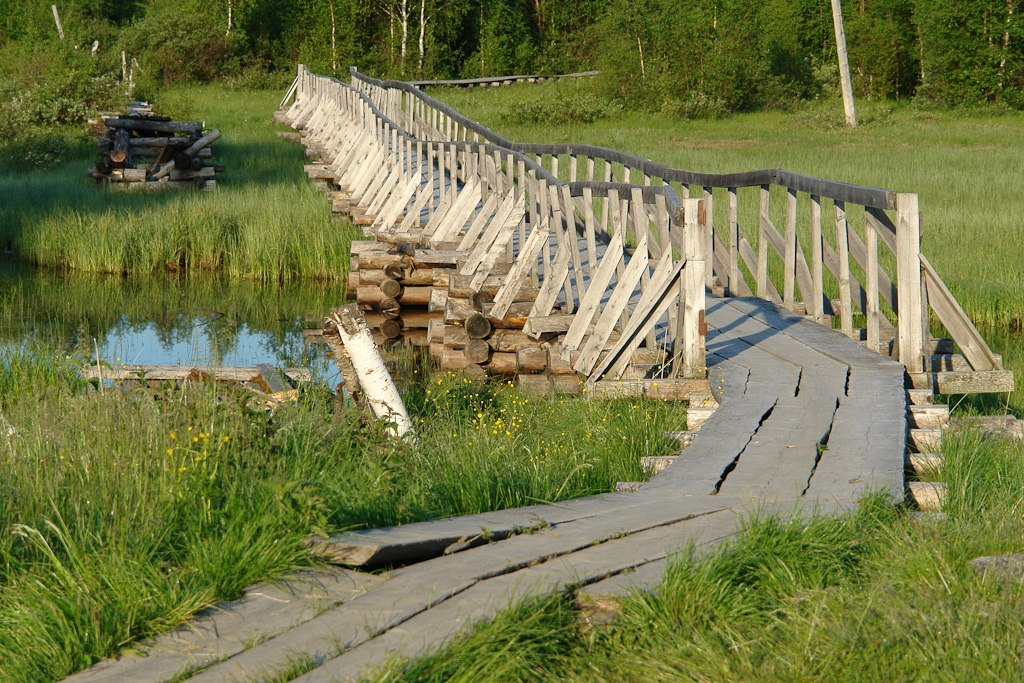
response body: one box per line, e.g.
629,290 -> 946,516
291,67 -> 708,380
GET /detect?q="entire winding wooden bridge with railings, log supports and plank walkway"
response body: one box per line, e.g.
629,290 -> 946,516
68,67 -> 1013,681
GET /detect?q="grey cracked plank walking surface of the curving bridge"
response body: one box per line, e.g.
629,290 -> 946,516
70,297 -> 906,683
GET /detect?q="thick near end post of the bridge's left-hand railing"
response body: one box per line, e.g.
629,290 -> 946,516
681,199 -> 708,378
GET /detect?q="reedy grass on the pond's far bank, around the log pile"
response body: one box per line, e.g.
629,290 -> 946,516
0,86 -> 357,281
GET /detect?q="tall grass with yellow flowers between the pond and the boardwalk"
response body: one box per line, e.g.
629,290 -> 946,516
0,350 -> 683,681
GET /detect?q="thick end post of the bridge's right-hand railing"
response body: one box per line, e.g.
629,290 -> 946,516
896,194 -> 925,373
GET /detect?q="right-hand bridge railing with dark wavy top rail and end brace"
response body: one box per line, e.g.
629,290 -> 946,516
351,69 -> 1001,382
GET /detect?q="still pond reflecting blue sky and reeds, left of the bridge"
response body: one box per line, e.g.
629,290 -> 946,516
0,255 -> 345,386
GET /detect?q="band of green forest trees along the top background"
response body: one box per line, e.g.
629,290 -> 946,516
0,0 -> 1024,160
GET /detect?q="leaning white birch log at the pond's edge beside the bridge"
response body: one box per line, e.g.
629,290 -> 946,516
328,304 -> 413,436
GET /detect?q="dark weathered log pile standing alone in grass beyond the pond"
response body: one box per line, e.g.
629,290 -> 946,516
88,102 -> 224,189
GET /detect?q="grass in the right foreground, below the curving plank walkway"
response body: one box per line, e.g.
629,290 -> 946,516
377,434 -> 1024,681
